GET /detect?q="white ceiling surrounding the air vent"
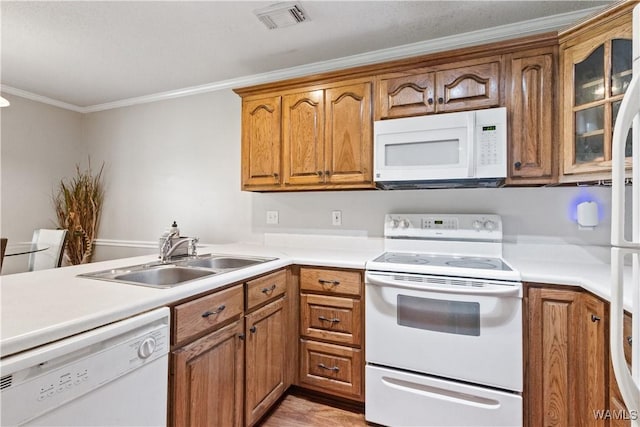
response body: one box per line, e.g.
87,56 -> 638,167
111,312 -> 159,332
0,0 -> 610,107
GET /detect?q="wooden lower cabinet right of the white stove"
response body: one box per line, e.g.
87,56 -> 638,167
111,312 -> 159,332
523,284 -> 631,427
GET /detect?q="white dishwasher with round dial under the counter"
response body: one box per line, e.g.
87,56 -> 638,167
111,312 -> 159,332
0,307 -> 169,426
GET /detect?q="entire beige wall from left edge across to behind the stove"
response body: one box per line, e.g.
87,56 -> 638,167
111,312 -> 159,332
2,90 -> 624,270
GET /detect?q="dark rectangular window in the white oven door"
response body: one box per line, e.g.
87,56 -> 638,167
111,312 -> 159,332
398,295 -> 480,337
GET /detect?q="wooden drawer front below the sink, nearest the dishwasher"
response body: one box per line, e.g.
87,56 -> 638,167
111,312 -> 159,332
173,284 -> 244,344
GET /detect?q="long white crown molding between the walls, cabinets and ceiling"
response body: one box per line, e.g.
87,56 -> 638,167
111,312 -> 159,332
1,7 -> 602,114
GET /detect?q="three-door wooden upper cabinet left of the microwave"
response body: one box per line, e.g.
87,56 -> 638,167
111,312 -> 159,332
242,80 -> 373,191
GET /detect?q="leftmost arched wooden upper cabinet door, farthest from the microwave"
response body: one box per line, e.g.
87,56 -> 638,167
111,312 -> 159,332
242,96 -> 281,189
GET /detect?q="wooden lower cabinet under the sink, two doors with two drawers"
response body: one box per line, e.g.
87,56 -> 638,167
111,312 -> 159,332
169,269 -> 290,427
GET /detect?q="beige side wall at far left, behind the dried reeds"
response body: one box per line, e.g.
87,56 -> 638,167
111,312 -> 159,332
0,94 -> 87,273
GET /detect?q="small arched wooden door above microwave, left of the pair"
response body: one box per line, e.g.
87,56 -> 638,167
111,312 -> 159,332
378,72 -> 435,119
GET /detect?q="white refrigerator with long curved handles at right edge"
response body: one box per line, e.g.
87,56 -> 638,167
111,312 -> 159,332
611,5 -> 640,427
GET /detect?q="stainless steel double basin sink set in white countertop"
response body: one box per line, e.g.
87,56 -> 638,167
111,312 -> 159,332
78,254 -> 277,288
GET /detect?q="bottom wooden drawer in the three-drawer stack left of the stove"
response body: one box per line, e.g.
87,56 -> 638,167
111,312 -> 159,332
300,340 -> 363,400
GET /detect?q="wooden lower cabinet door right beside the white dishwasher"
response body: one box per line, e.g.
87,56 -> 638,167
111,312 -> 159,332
171,320 -> 244,427
